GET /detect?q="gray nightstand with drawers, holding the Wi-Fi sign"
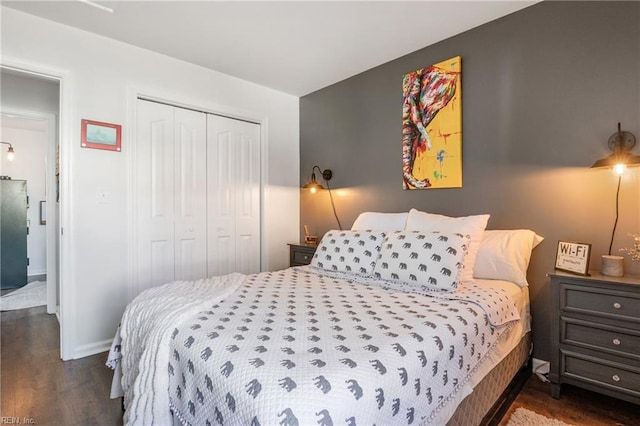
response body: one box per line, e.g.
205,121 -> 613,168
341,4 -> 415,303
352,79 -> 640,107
549,271 -> 640,404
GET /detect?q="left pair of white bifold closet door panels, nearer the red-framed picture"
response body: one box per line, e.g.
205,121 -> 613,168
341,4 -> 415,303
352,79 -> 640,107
136,101 -> 207,291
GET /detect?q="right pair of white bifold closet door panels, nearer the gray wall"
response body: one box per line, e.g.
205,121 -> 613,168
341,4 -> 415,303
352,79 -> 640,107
207,115 -> 260,275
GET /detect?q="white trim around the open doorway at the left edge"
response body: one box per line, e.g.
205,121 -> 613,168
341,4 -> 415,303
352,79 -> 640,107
0,57 -> 76,360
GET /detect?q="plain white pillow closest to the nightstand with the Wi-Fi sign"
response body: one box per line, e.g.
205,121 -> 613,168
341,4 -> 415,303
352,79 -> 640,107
473,229 -> 544,287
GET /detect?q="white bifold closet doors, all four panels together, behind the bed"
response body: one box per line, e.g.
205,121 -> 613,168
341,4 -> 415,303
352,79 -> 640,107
134,99 -> 261,292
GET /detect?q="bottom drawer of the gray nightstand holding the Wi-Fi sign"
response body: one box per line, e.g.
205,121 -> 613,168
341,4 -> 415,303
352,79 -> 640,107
563,353 -> 640,396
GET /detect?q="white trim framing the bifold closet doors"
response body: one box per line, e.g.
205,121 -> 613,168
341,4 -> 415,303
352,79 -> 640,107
126,86 -> 269,301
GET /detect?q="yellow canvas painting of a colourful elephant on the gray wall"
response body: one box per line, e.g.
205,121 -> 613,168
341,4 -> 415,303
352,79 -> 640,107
402,56 -> 462,189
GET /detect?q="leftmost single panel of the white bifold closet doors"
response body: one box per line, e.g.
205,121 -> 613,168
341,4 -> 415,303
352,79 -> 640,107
136,101 -> 175,292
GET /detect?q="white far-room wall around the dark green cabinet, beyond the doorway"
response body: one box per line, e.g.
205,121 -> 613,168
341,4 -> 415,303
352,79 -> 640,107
0,119 -> 49,276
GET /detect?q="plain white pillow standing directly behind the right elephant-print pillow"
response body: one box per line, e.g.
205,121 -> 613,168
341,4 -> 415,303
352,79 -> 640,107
405,209 -> 490,282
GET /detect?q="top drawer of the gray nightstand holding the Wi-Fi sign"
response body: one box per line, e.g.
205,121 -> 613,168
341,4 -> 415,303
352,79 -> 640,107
560,285 -> 640,322
